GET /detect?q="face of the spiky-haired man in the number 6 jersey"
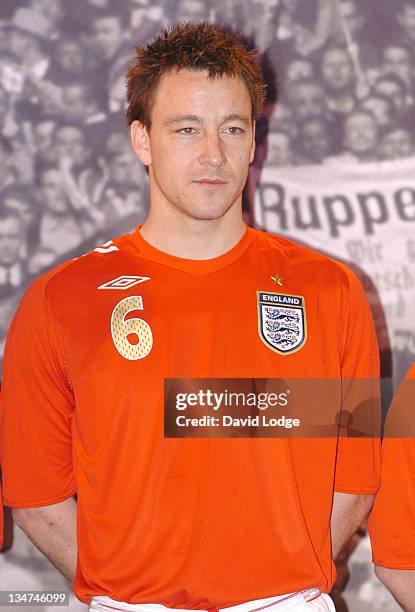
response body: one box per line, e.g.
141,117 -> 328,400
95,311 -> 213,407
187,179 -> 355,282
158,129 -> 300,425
132,70 -> 255,219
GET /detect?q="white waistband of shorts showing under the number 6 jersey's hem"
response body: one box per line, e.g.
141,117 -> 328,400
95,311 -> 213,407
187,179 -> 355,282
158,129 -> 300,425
90,588 -> 320,612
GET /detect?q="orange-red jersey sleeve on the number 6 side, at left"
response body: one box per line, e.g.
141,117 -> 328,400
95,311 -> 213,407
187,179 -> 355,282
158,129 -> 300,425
0,277 -> 76,508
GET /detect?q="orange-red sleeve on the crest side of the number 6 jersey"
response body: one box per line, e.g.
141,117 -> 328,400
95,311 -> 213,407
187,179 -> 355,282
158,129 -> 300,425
334,269 -> 381,494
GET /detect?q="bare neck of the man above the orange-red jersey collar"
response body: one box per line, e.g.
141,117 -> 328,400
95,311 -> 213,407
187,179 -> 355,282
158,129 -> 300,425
141,202 -> 246,260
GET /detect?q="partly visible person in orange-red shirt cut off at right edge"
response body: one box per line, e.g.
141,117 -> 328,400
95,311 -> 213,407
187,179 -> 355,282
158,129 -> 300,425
369,364 -> 415,612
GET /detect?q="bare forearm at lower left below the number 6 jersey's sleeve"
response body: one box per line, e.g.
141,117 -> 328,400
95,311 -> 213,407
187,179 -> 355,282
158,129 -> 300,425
12,497 -> 77,583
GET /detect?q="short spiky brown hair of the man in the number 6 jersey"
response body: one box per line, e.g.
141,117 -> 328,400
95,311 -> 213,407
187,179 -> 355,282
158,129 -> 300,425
126,22 -> 265,129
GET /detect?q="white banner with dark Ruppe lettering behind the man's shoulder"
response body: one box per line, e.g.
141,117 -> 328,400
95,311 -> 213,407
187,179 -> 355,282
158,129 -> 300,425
254,158 -> 415,378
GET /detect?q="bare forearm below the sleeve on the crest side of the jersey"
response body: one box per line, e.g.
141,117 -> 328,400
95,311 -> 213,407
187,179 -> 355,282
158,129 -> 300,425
331,492 -> 375,559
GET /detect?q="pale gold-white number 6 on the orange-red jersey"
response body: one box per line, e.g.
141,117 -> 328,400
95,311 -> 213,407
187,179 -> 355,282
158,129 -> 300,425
111,295 -> 153,361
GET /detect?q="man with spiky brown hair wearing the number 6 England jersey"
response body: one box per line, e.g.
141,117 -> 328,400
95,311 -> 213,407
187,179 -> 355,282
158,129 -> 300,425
1,23 -> 379,612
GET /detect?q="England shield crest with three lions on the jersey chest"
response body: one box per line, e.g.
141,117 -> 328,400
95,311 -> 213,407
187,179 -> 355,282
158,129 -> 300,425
257,291 -> 307,355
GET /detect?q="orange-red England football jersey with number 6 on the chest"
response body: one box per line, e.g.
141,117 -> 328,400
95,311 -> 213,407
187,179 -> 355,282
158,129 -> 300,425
1,227 -> 380,609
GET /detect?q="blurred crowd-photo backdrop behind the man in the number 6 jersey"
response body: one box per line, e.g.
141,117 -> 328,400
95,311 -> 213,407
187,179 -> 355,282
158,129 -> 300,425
0,0 -> 415,611
